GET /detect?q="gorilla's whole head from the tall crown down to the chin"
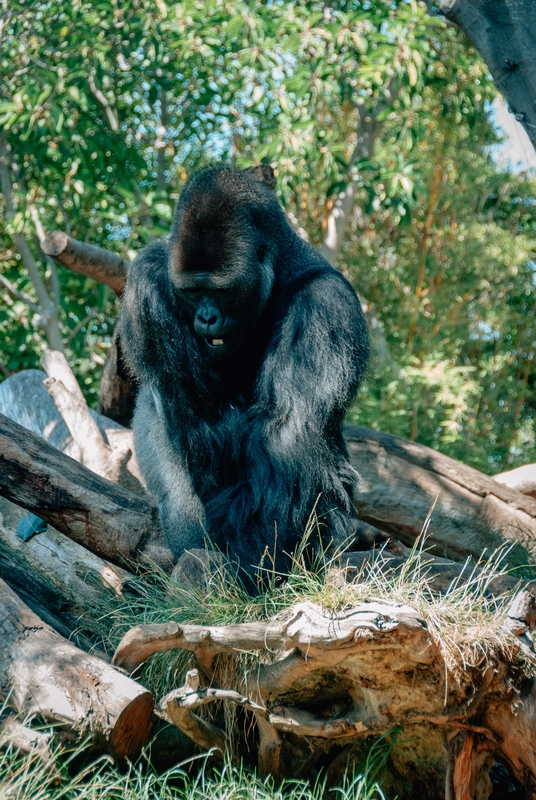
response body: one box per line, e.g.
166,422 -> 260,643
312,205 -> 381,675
169,170 -> 279,359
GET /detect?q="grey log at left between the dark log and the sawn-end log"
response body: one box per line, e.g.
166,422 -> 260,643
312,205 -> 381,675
0,497 -> 136,650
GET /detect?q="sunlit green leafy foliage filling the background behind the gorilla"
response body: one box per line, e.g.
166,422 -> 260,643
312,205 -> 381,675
0,0 -> 536,472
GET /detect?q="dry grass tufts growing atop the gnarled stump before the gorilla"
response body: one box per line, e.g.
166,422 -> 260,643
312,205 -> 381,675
96,506 -> 532,696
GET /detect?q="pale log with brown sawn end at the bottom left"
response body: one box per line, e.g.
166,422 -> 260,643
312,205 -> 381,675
0,580 -> 154,758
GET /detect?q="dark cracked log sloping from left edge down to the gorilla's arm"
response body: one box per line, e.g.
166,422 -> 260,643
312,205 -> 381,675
0,415 -> 173,569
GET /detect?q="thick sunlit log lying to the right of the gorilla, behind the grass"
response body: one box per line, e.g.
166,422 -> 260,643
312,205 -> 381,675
344,425 -> 536,566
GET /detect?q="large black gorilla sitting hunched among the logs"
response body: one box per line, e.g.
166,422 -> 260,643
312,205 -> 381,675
121,167 -> 368,571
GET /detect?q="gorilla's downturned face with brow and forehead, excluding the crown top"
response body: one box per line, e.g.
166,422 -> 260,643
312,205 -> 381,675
169,197 -> 275,359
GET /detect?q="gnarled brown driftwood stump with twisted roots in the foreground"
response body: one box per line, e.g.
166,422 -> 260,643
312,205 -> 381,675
114,602 -> 536,800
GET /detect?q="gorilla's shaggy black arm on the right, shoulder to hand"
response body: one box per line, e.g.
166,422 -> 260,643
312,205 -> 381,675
254,273 -> 368,532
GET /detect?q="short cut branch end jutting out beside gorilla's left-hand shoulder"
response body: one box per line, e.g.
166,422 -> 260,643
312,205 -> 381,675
41,231 -> 128,296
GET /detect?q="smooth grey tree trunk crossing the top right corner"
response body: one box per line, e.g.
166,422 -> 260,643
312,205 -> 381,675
438,0 -> 536,155
